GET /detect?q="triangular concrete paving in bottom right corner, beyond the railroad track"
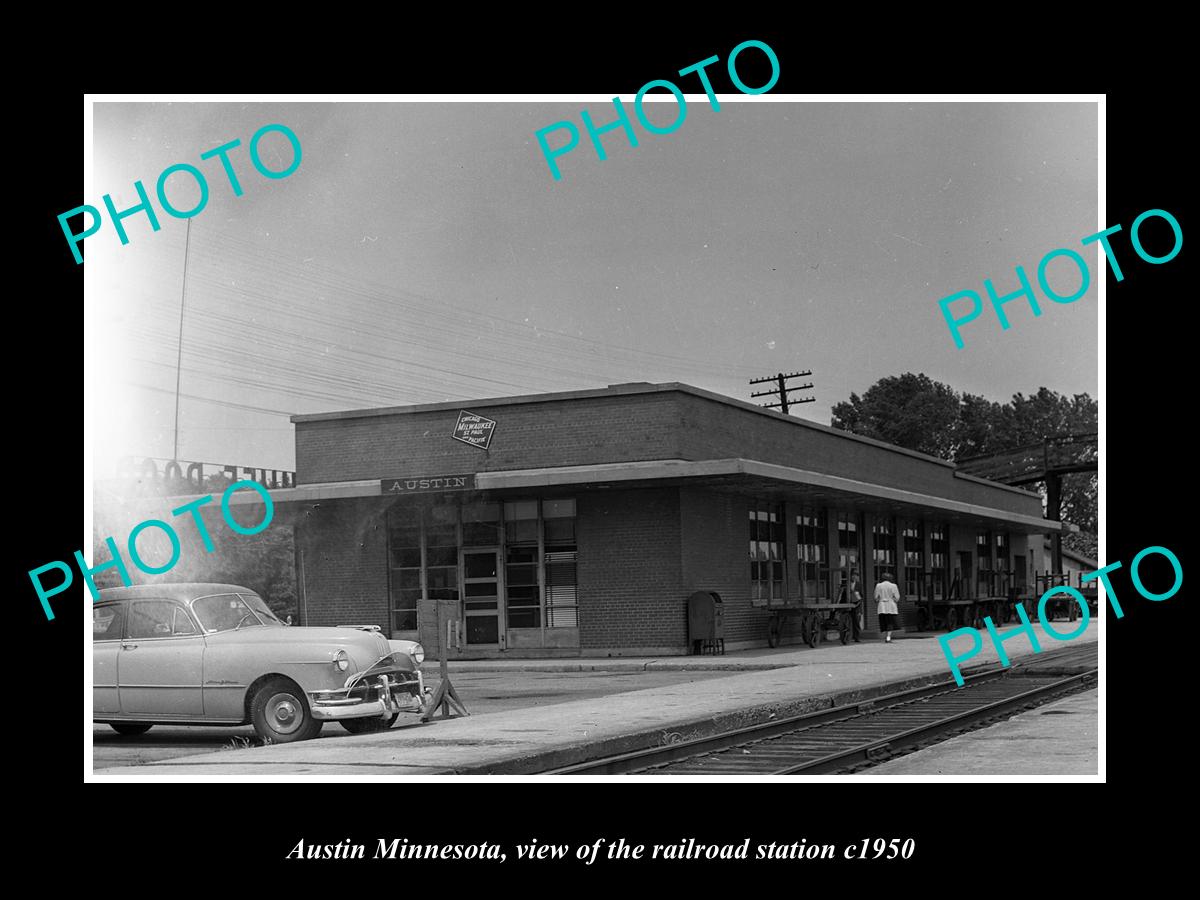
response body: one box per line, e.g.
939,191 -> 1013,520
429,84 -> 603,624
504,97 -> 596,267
860,690 -> 1099,775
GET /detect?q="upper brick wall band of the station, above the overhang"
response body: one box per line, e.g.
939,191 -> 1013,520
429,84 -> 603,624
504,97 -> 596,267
296,389 -> 1042,528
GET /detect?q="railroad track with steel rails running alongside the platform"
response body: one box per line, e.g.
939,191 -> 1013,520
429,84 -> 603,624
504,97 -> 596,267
546,650 -> 1098,775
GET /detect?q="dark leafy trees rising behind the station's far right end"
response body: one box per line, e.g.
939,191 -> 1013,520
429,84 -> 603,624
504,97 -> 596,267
832,372 -> 1099,534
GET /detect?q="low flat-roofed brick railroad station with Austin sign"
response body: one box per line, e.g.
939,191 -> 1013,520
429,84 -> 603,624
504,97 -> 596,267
260,383 -> 1060,659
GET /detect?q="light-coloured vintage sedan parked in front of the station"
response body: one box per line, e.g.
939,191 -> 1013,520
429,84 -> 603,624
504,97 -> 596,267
92,584 -> 425,744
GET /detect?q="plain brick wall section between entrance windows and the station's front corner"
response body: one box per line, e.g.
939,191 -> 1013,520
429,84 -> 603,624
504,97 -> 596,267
576,488 -> 688,656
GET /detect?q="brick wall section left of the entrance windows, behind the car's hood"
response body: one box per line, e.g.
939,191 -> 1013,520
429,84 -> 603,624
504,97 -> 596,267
296,500 -> 390,634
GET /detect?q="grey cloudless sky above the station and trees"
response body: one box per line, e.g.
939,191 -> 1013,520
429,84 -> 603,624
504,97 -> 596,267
84,101 -> 1104,478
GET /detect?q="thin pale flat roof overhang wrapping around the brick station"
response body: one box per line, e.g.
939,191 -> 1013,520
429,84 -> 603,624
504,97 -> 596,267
213,458 -> 1078,534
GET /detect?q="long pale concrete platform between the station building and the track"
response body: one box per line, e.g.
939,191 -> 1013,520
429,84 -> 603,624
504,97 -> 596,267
94,620 -> 1098,780
